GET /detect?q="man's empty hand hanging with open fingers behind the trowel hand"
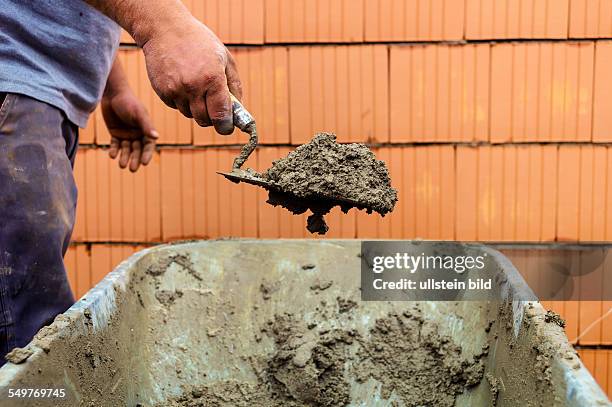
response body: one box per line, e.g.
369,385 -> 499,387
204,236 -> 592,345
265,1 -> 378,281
101,61 -> 159,172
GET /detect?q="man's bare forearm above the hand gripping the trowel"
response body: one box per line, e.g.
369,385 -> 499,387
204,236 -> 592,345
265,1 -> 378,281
84,0 -> 192,47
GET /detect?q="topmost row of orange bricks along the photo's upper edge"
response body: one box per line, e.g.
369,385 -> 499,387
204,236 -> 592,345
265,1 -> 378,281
116,0 -> 612,44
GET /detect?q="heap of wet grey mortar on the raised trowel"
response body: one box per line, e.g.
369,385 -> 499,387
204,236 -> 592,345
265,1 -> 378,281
262,133 -> 397,234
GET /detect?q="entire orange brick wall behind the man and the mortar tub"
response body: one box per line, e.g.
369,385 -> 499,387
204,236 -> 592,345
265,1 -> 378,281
66,0 -> 612,392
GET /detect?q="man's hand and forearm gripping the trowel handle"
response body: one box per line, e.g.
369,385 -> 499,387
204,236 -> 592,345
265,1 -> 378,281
85,0 -> 242,135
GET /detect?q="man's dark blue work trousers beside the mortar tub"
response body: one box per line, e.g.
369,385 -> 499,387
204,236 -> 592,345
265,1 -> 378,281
0,93 -> 78,365
